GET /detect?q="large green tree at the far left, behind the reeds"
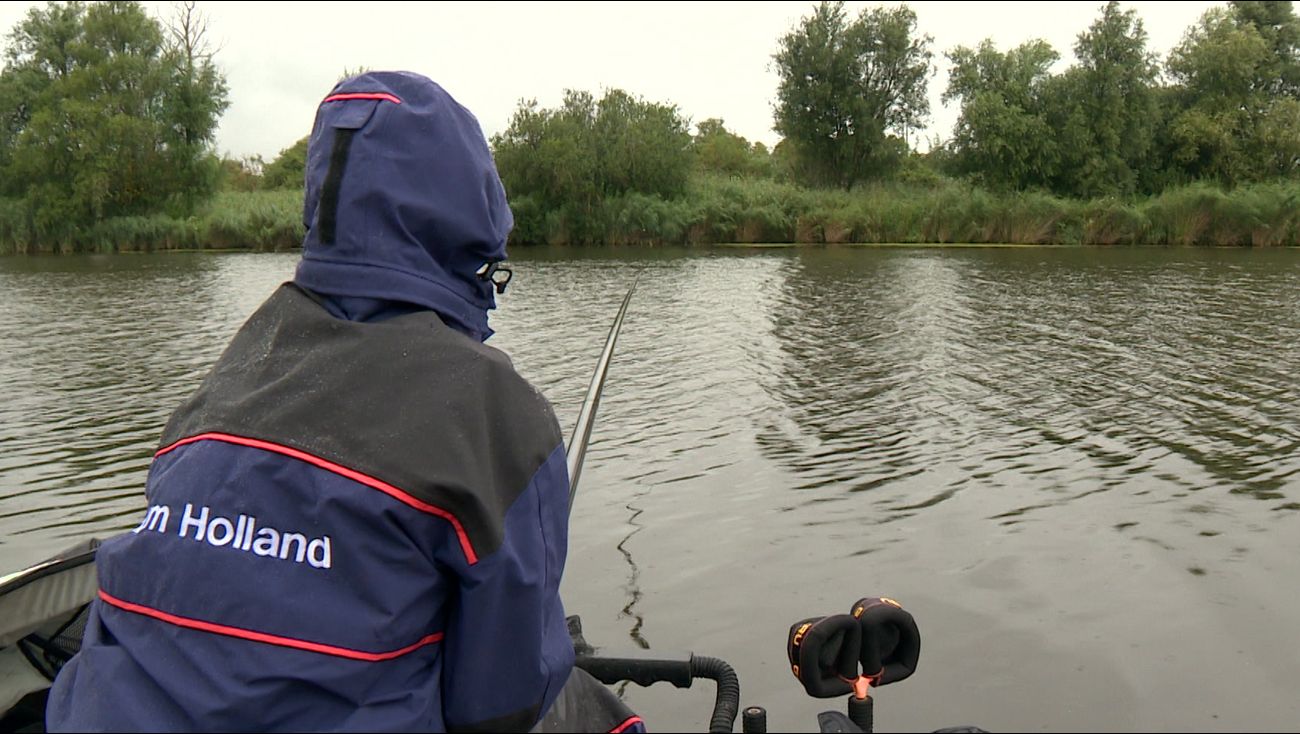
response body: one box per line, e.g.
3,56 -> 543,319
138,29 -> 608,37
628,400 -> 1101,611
0,1 -> 226,240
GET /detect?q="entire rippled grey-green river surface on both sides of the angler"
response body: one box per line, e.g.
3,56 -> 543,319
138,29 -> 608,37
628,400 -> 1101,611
0,248 -> 1300,730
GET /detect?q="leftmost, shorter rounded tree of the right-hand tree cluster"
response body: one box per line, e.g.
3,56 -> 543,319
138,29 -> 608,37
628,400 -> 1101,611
943,40 -> 1060,190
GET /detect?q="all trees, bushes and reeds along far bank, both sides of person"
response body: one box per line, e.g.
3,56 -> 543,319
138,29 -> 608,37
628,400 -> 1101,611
0,0 -> 1300,249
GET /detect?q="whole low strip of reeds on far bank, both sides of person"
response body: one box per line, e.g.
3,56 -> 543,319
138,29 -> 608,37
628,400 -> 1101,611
0,175 -> 1300,253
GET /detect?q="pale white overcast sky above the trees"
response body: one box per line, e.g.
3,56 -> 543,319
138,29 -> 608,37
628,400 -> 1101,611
0,0 -> 1226,161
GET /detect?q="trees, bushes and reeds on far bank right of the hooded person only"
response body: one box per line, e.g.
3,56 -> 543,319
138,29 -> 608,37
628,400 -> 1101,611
480,1 -> 1300,244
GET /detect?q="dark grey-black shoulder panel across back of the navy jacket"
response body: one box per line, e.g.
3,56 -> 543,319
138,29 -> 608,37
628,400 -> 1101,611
161,283 -> 562,556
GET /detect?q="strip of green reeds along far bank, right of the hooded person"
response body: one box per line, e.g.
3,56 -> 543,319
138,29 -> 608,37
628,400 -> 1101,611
577,178 -> 1300,247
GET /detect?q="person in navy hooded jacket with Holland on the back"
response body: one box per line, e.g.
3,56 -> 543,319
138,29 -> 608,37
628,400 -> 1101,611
47,71 -> 644,731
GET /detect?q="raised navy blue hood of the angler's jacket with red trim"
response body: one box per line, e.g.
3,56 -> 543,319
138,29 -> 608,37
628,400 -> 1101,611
294,71 -> 515,340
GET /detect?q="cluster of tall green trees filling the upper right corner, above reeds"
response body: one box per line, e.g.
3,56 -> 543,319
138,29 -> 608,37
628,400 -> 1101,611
943,1 -> 1300,197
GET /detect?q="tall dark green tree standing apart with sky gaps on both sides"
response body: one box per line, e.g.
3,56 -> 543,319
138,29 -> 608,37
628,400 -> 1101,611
774,0 -> 933,188
